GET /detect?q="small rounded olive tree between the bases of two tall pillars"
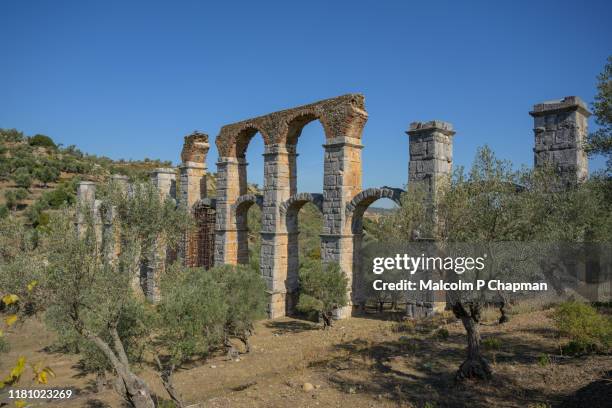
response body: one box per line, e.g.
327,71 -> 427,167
297,261 -> 348,329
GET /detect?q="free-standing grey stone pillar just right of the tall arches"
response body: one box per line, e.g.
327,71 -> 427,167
406,120 -> 455,200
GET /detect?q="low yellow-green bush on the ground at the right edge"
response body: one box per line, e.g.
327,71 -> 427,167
553,301 -> 612,354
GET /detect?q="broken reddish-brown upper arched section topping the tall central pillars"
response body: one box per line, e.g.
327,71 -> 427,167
215,94 -> 368,157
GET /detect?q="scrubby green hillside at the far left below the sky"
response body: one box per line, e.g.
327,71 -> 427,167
0,129 -> 172,226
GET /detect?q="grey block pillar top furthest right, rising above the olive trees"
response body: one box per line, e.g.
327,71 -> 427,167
529,96 -> 591,185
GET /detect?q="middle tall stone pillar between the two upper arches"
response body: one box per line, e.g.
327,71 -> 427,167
260,144 -> 295,319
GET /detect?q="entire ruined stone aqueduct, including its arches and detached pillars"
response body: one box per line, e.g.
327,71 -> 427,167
78,94 -> 590,318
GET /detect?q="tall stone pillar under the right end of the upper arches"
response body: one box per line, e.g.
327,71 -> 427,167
321,136 -> 363,318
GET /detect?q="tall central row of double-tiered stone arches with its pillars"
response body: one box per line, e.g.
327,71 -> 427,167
215,94 -> 399,317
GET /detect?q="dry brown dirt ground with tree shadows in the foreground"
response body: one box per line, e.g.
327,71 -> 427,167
0,311 -> 612,408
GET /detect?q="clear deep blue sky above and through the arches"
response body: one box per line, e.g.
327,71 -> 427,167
0,0 -> 612,191
